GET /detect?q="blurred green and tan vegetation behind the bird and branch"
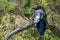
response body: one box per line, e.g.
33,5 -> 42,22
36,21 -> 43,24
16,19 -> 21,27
0,0 -> 60,40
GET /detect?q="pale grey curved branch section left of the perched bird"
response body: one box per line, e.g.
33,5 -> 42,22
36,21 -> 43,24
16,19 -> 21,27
4,23 -> 34,40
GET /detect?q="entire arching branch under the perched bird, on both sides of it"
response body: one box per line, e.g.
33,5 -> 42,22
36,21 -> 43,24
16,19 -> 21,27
4,23 -> 60,40
